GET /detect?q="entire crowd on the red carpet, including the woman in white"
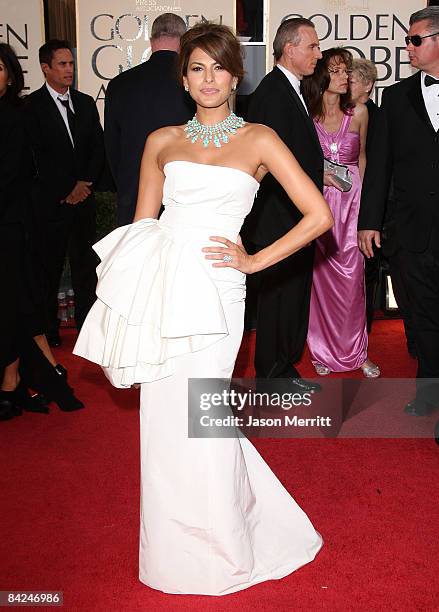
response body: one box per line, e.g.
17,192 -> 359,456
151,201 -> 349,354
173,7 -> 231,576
0,2 -> 439,595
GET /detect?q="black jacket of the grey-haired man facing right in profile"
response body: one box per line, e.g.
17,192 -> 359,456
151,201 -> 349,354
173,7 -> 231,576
243,67 -> 323,247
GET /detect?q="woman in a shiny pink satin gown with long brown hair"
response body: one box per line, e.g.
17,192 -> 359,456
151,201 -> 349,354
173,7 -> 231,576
304,48 -> 380,378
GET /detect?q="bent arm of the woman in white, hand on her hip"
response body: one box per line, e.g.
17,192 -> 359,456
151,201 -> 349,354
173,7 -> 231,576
203,125 -> 334,274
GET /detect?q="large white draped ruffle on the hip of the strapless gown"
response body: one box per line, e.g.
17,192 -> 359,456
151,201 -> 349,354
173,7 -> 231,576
73,219 -> 228,388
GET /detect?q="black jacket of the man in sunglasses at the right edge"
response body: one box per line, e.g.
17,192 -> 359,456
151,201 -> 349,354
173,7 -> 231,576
358,72 -> 439,253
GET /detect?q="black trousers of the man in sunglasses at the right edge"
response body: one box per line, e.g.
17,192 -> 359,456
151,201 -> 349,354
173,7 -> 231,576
399,239 -> 439,406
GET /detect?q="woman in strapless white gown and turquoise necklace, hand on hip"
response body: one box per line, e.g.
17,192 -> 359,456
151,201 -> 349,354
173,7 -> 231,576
74,24 -> 332,595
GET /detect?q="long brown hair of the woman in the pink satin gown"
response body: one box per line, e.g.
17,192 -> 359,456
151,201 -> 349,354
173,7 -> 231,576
302,47 -> 355,119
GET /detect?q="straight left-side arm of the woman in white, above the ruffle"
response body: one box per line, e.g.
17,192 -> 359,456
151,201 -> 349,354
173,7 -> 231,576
133,128 -> 166,223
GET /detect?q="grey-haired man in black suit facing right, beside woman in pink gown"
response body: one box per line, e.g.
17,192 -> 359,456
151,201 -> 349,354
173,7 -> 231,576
243,18 -> 323,391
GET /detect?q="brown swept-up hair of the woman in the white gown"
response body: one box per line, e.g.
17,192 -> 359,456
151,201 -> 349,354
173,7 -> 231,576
178,22 -> 244,84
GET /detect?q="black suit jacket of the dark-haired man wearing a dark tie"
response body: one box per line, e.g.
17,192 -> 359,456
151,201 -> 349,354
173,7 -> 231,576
25,85 -> 105,217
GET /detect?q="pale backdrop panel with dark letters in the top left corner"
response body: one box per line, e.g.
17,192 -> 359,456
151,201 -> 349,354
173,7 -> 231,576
0,0 -> 44,93
